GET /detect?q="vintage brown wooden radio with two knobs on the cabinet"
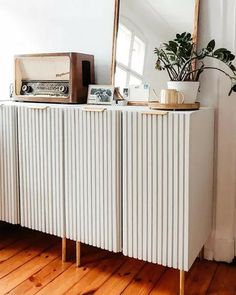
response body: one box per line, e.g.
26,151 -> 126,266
14,52 -> 94,103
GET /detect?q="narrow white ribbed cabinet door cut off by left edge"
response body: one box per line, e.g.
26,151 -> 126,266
0,105 -> 19,224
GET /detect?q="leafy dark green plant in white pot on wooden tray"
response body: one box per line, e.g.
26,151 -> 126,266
154,32 -> 236,103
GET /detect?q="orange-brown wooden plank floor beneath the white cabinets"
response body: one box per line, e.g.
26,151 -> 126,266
0,225 -> 236,295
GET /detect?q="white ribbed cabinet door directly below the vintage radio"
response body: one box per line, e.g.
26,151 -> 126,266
18,104 -> 64,236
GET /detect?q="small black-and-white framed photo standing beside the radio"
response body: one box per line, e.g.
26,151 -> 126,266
87,85 -> 115,104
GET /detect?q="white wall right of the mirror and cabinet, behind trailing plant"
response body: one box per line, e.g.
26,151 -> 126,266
199,0 -> 236,262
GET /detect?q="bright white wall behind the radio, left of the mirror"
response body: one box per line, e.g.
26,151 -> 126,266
0,0 -> 114,99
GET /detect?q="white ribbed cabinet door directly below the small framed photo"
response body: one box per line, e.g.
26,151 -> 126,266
64,106 -> 121,252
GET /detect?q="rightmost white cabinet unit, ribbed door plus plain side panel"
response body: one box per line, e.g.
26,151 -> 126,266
123,109 -> 214,271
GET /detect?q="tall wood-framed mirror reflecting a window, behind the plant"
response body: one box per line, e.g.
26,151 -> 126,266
112,0 -> 200,102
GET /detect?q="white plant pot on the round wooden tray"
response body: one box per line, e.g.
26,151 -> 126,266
167,81 -> 200,103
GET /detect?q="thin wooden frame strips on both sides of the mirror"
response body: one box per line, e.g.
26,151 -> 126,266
111,0 -> 200,85
